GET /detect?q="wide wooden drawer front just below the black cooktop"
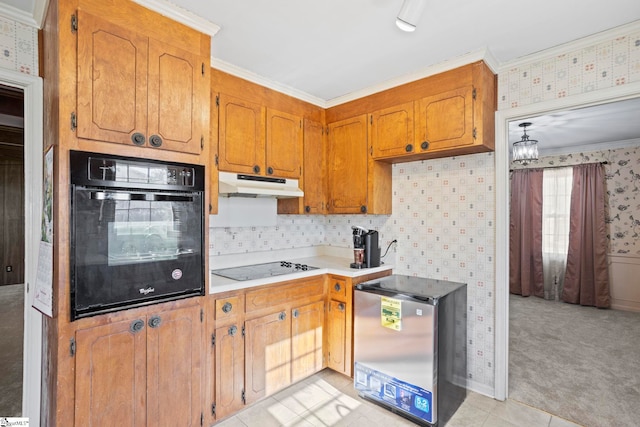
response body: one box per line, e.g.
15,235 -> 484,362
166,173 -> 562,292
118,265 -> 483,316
245,276 -> 324,313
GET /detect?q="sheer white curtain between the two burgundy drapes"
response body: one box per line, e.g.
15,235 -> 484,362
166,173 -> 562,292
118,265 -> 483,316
542,167 -> 573,300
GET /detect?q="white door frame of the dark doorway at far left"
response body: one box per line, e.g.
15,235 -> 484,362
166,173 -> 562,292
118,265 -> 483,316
0,68 -> 44,426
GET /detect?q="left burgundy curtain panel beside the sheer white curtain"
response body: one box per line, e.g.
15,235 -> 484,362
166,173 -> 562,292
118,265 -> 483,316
509,169 -> 544,298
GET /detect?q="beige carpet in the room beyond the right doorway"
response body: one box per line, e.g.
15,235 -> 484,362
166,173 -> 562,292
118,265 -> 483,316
509,295 -> 640,427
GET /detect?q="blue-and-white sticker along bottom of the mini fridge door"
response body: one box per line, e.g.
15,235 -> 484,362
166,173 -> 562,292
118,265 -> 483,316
354,362 -> 434,424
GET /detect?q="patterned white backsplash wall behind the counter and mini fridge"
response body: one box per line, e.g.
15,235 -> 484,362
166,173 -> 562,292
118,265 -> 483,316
209,153 -> 495,394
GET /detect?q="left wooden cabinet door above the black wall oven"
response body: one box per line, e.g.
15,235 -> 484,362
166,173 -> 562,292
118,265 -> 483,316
77,10 -> 148,144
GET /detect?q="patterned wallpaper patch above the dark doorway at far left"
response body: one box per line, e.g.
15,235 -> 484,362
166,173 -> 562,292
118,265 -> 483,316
0,17 -> 38,75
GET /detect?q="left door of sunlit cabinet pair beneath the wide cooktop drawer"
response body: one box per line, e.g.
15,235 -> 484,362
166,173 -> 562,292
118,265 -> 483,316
245,311 -> 291,404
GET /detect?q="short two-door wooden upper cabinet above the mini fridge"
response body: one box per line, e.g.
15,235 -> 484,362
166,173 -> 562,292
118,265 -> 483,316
327,62 -> 496,163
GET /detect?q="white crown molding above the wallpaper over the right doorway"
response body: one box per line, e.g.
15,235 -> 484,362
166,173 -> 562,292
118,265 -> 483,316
497,20 -> 640,74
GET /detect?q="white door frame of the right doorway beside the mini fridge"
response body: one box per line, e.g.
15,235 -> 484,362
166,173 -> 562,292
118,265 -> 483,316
494,82 -> 640,400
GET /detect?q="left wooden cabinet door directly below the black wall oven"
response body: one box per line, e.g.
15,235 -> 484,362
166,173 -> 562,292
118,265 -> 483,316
75,319 -> 147,427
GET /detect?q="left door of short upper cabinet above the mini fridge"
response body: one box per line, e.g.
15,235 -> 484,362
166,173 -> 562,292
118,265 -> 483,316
369,102 -> 415,159
